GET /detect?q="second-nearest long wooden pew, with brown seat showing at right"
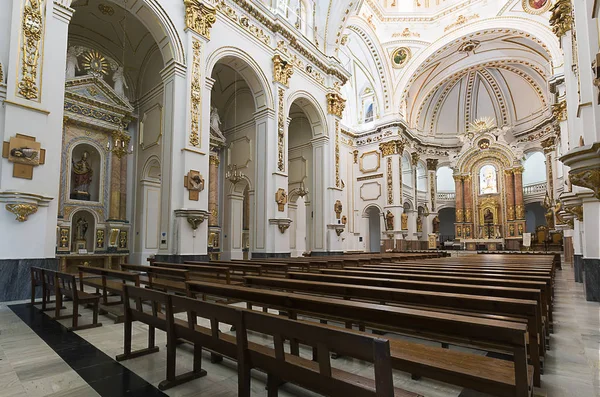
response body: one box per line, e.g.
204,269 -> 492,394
187,281 -> 533,396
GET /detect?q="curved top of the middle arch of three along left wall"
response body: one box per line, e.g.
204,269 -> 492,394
206,47 -> 274,111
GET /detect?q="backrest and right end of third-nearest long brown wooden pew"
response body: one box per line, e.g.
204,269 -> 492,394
245,277 -> 546,379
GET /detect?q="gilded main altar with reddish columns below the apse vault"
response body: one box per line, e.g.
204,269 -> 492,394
451,128 -> 526,250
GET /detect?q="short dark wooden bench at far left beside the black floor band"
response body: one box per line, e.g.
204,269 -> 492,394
52,270 -> 102,331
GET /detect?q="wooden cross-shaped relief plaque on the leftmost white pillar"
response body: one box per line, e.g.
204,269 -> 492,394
2,134 -> 46,179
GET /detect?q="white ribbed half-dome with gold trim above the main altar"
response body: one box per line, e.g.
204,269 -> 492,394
403,29 -> 551,136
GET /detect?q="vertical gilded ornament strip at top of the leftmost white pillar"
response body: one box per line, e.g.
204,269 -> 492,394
17,0 -> 45,100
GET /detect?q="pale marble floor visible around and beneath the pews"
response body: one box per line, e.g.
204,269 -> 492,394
0,265 -> 600,397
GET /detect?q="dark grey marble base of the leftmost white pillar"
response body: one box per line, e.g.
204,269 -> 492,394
0,258 -> 59,302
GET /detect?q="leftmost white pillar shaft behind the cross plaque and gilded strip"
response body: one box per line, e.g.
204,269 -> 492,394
0,0 -> 74,259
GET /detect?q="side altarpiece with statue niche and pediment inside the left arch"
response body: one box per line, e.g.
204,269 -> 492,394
56,75 -> 133,272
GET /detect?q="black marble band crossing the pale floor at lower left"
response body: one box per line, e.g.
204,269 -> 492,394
9,304 -> 167,397
